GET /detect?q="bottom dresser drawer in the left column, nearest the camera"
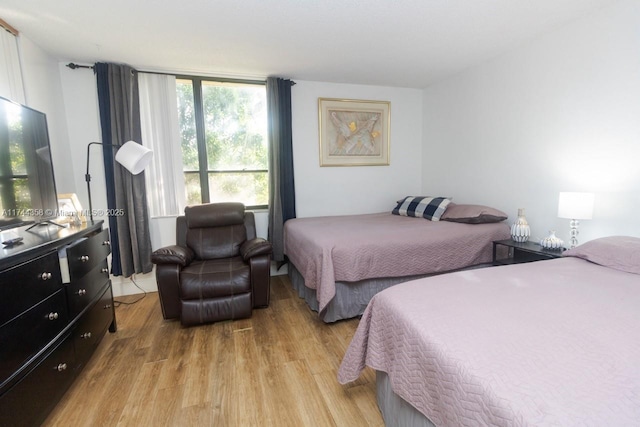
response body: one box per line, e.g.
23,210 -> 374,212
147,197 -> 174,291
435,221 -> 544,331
0,337 -> 76,426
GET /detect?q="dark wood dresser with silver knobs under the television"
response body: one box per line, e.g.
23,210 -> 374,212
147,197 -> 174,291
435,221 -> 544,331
0,221 -> 116,426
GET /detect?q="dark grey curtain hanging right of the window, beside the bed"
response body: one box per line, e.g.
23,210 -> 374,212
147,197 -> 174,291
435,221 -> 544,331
267,77 -> 296,263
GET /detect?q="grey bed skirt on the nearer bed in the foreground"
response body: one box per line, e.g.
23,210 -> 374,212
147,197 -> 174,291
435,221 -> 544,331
376,371 -> 435,427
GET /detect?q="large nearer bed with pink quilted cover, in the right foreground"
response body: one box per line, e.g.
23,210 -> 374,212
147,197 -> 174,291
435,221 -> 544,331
338,236 -> 640,426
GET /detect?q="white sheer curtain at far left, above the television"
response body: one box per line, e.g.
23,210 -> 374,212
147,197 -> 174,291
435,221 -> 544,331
0,27 -> 25,104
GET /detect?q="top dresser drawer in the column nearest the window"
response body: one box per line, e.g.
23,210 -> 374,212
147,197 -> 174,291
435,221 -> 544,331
67,230 -> 111,283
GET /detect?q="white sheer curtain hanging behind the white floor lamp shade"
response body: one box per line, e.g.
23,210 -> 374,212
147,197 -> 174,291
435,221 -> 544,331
138,73 -> 186,217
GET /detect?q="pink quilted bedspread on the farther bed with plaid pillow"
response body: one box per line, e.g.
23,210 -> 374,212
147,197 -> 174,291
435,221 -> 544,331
284,213 -> 509,311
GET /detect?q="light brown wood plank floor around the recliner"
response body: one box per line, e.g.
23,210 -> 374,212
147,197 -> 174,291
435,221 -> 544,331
45,276 -> 384,427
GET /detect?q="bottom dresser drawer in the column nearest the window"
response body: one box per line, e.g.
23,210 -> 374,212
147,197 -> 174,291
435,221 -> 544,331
72,286 -> 114,367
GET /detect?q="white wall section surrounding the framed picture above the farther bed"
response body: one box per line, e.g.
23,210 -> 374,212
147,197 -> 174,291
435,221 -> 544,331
291,81 -> 422,217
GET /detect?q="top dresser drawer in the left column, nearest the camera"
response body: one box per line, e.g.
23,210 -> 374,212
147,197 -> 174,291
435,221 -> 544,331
0,252 -> 62,325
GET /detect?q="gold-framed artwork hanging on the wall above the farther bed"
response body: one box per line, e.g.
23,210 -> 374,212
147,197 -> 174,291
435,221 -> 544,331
318,98 -> 391,166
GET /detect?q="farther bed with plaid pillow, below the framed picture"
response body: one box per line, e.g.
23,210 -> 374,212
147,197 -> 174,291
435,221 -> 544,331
284,198 -> 509,323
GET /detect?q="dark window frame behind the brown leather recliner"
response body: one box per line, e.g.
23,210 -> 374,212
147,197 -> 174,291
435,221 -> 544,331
175,74 -> 269,210
